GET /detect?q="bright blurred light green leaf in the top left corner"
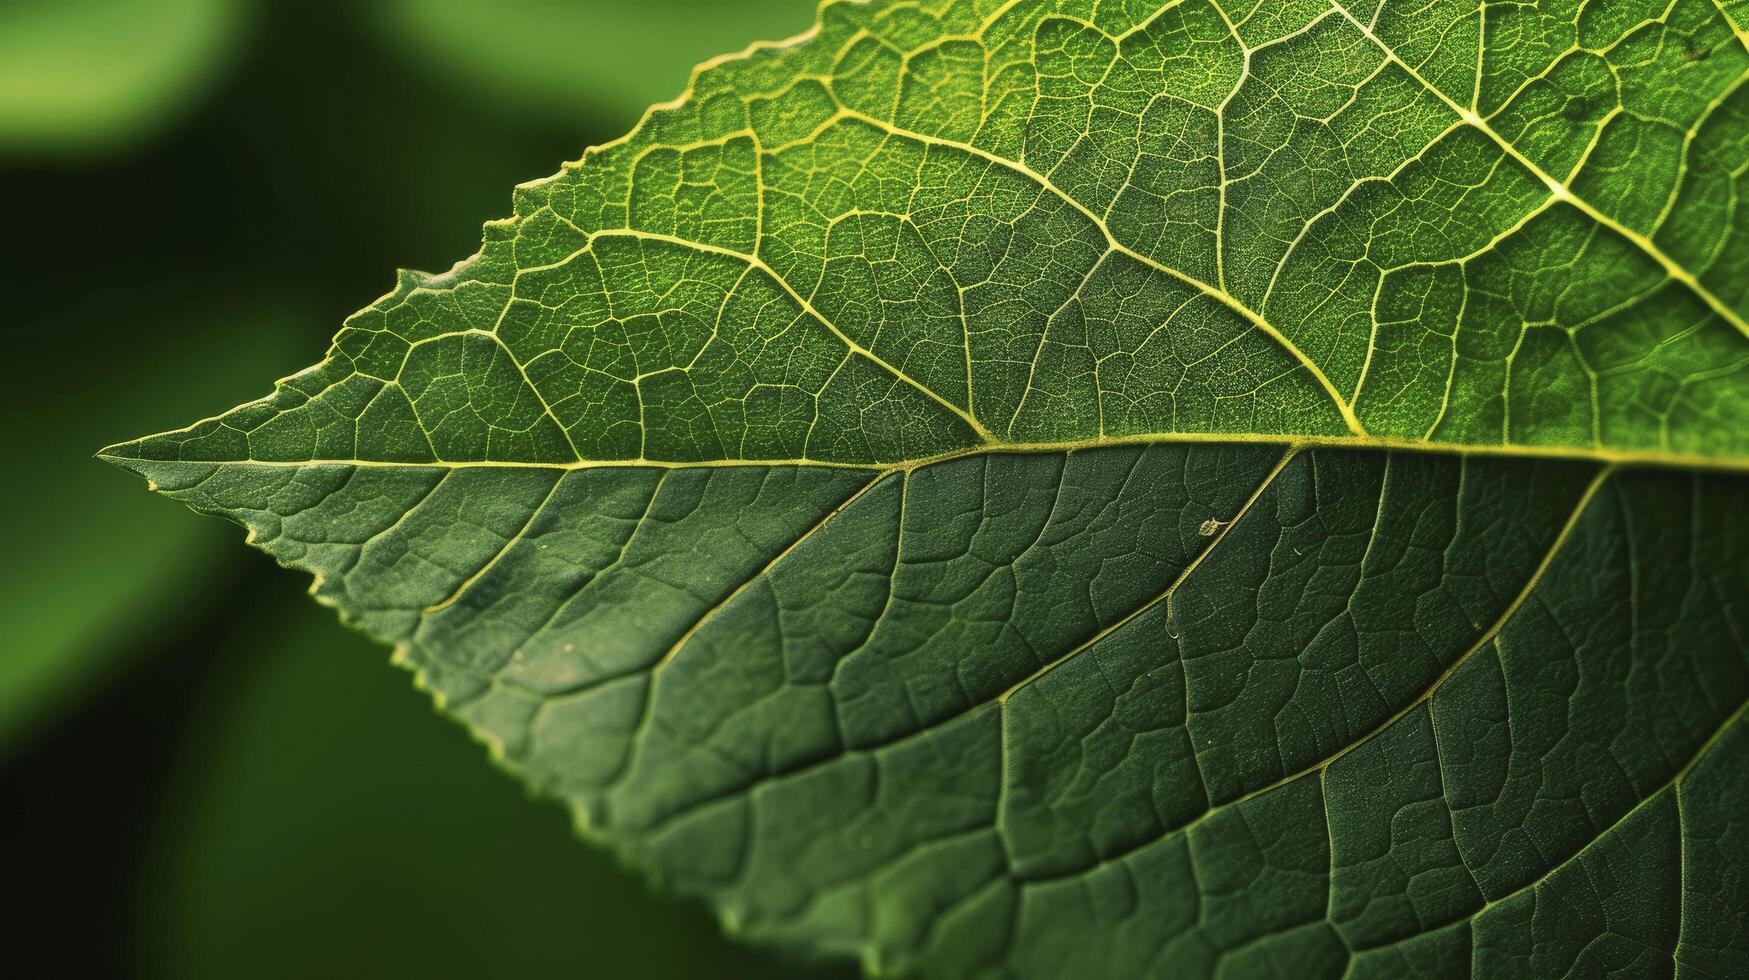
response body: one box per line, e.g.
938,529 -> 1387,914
0,0 -> 245,154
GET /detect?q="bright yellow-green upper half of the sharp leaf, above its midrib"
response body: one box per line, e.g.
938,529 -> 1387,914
109,0 -> 1749,462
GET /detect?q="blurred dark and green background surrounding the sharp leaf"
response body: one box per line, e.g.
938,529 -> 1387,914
0,0 -> 848,978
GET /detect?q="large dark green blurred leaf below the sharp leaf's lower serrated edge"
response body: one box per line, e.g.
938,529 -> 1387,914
138,597 -> 846,980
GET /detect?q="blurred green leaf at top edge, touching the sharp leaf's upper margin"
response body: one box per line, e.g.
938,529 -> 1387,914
364,0 -> 815,121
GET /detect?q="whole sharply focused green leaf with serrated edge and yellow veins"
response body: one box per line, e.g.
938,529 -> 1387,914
105,0 -> 1749,977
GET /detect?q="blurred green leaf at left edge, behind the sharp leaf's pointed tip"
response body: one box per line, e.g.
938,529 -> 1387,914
0,294 -> 308,747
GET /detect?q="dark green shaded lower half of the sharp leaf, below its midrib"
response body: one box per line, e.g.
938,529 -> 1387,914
109,443 -> 1749,977
